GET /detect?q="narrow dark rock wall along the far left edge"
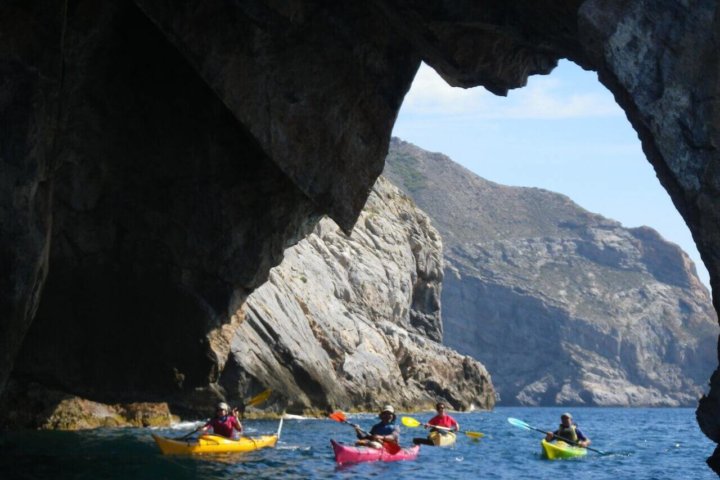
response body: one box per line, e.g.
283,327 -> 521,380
0,1 -> 62,408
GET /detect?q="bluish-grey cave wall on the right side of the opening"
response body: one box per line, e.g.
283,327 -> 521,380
580,1 -> 720,473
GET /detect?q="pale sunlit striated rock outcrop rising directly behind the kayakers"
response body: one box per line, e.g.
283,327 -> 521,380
213,177 -> 495,411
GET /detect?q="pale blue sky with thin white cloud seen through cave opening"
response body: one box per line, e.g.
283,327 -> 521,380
393,61 -> 709,285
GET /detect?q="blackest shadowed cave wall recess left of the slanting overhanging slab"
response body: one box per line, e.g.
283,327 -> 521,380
9,2 -> 319,399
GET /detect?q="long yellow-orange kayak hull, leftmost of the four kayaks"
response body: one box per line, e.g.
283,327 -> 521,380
152,433 -> 278,455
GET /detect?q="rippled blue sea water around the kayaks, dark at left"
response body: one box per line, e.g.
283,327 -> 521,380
0,407 -> 718,480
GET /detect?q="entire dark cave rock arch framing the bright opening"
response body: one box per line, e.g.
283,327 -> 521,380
0,0 -> 720,471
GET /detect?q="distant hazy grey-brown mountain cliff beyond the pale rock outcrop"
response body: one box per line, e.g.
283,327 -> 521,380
385,139 -> 718,406
